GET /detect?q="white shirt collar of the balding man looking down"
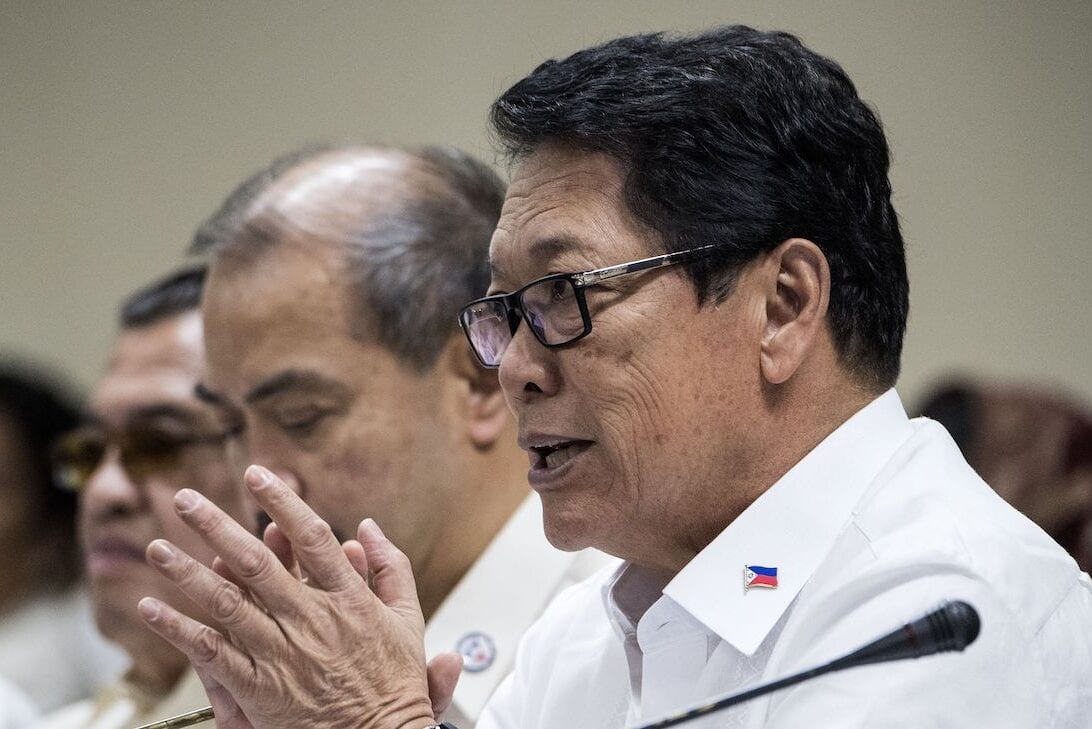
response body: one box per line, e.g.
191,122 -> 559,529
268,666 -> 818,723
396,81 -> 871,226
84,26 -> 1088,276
425,494 -> 581,724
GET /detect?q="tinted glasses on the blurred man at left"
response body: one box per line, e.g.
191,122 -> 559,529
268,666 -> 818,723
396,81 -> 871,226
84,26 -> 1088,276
51,426 -> 232,491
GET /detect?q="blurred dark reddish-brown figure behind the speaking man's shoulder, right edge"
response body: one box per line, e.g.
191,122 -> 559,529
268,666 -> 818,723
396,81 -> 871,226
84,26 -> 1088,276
921,380 -> 1092,572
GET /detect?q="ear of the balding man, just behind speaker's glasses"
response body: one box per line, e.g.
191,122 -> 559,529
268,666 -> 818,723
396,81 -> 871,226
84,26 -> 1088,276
443,336 -> 511,450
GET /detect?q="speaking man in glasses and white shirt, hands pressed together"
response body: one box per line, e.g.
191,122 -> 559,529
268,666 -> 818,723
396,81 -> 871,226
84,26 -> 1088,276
141,26 -> 1092,729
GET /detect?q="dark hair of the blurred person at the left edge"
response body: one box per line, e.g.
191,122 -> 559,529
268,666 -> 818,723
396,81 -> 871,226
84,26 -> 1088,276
0,365 -> 83,598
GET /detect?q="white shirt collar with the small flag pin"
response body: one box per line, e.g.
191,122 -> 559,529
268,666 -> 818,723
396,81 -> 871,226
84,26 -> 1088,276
664,390 -> 914,656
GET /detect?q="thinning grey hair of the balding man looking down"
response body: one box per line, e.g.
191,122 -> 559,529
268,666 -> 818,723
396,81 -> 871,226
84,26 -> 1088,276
190,145 -> 505,372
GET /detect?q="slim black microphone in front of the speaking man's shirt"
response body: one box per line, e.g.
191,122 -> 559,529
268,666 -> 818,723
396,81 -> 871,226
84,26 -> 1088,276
634,600 -> 982,729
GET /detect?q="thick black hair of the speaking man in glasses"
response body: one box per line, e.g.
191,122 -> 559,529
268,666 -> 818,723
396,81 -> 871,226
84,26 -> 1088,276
491,25 -> 909,387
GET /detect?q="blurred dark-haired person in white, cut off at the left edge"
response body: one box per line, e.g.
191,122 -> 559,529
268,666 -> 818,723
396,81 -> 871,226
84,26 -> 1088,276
0,367 -> 121,726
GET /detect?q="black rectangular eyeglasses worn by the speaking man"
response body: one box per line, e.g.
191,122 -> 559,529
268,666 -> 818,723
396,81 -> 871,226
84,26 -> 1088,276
459,244 -> 721,369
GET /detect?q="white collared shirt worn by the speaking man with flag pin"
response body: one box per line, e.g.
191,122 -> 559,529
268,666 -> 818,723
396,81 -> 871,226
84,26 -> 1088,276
478,390 -> 1092,729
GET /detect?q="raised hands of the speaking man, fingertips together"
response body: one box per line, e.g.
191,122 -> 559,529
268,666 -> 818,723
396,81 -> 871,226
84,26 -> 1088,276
138,466 -> 460,729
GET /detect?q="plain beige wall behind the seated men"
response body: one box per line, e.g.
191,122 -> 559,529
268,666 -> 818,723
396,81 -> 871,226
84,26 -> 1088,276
0,0 -> 1092,402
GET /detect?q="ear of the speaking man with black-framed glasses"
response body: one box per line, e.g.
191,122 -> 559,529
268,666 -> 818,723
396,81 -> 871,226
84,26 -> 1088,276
760,238 -> 830,385
